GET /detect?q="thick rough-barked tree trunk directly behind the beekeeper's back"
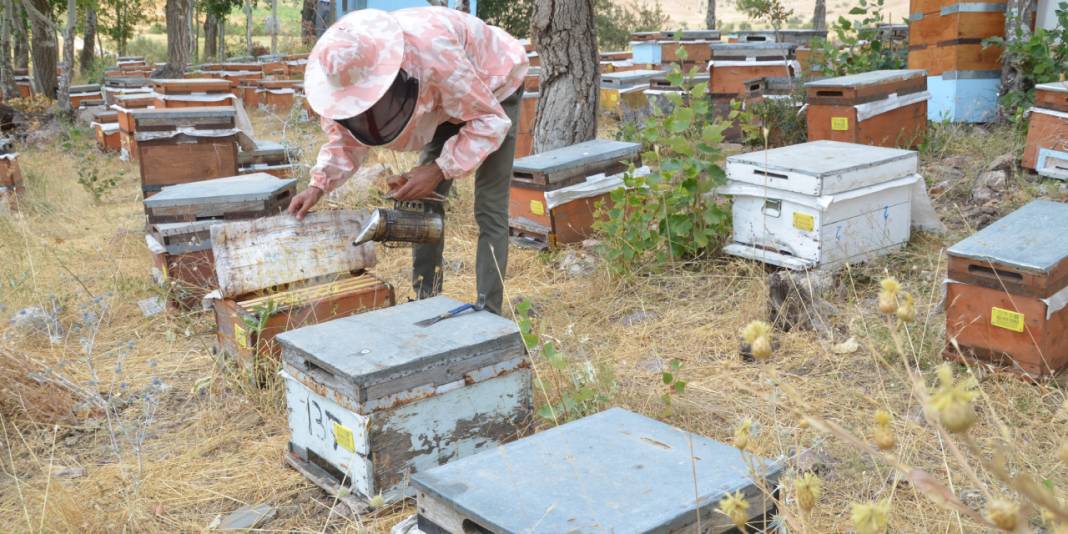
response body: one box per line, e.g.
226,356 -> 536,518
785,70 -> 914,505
531,0 -> 600,153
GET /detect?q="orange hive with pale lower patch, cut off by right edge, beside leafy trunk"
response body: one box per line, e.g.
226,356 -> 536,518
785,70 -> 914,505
1023,81 -> 1068,179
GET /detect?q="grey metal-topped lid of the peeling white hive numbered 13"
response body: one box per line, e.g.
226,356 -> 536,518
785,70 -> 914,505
277,296 -> 525,402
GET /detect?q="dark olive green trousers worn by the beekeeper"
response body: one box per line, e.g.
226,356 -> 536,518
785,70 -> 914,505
411,88 -> 523,315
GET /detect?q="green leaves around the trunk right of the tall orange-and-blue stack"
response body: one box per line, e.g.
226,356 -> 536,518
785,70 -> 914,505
984,2 -> 1068,131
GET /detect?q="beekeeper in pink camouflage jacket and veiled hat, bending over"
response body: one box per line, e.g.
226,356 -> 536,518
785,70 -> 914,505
289,7 -> 528,314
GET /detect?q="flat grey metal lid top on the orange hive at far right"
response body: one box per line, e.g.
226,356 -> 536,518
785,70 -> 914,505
947,200 -> 1068,273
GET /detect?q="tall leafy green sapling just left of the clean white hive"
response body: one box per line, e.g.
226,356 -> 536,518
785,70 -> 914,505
594,54 -> 737,273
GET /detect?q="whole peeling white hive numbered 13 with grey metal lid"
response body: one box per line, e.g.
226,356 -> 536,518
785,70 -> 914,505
278,296 -> 532,502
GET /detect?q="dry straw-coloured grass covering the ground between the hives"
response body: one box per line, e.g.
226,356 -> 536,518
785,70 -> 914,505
0,106 -> 1068,533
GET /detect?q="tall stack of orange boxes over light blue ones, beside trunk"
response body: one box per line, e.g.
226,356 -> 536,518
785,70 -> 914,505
909,0 -> 1005,123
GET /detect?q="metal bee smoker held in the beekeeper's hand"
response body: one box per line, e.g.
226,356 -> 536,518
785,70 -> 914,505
352,199 -> 445,247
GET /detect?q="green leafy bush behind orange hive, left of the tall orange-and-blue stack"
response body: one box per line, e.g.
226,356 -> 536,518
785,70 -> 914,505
813,0 -> 908,77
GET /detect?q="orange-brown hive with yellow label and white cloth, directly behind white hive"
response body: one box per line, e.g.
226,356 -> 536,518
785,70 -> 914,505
805,70 -> 930,146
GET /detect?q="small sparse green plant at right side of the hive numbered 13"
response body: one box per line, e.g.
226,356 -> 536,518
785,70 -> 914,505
516,299 -> 616,423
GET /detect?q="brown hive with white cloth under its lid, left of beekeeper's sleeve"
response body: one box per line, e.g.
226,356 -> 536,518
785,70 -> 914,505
131,107 -> 240,198
